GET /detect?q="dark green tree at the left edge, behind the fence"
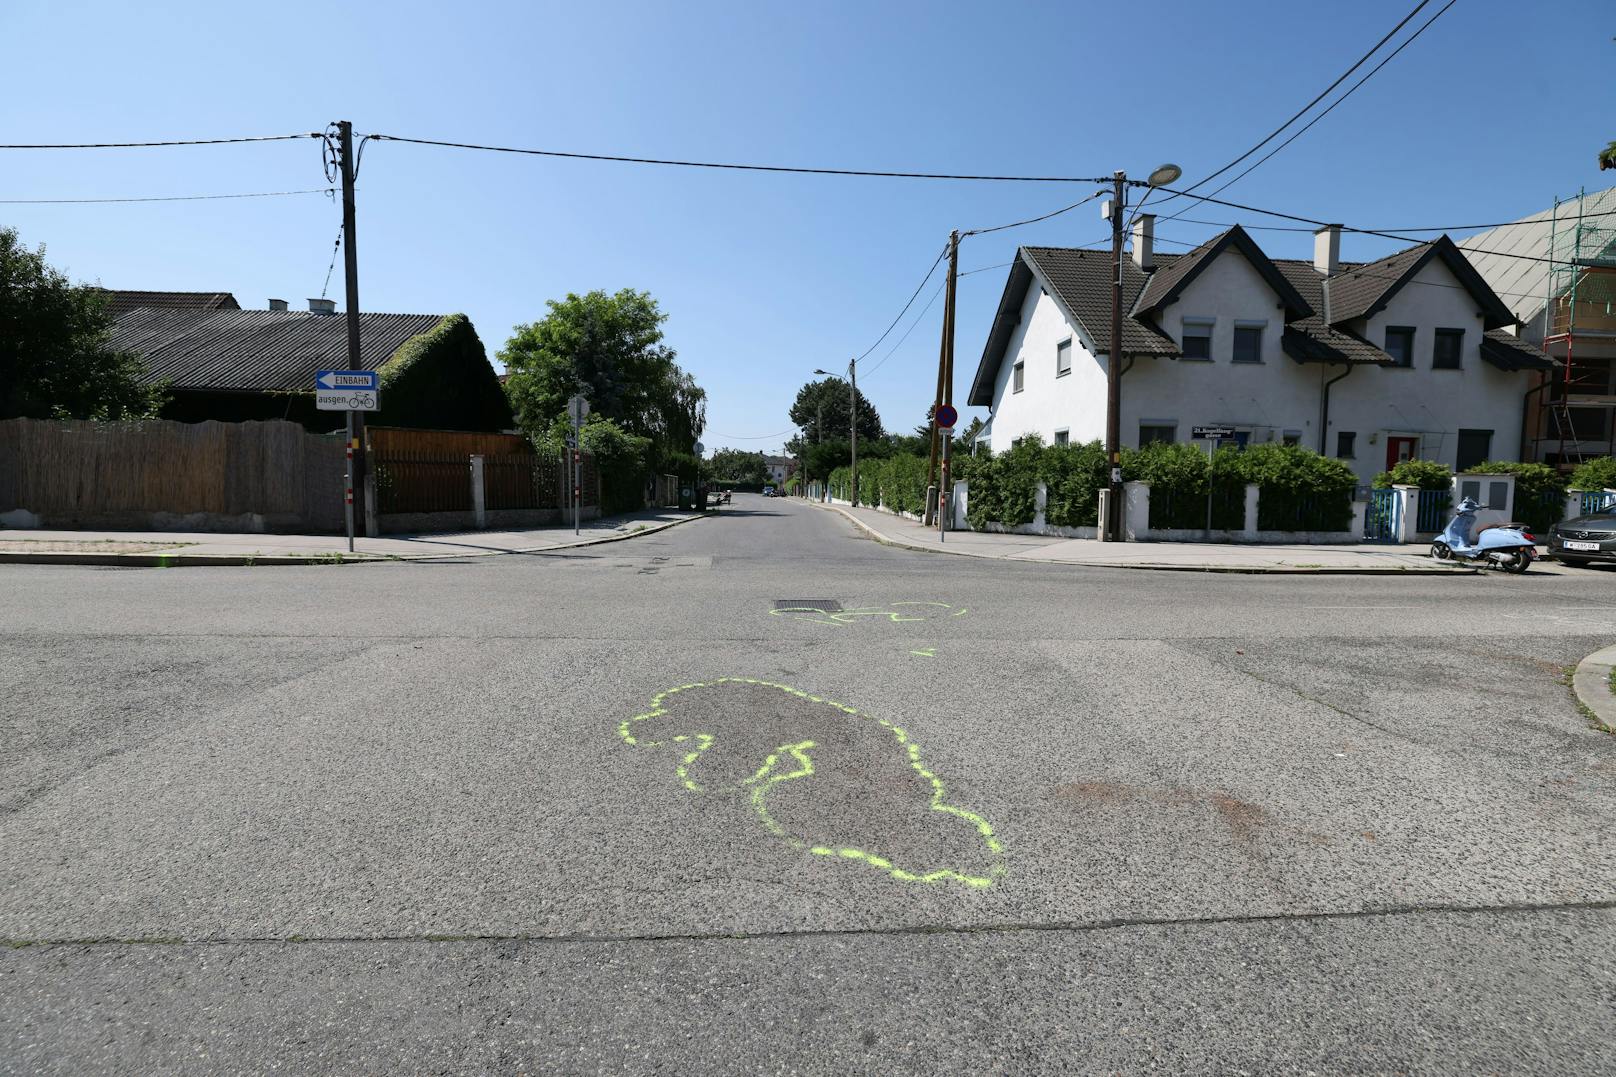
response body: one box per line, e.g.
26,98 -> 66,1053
0,228 -> 166,420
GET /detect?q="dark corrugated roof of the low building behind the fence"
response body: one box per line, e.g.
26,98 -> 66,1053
112,307 -> 443,393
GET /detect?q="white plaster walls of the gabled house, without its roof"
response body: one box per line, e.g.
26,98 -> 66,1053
983,246 -> 1534,484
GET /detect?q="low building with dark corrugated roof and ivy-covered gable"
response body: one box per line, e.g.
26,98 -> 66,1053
108,291 -> 514,432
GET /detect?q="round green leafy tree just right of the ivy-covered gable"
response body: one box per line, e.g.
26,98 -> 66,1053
499,288 -> 706,467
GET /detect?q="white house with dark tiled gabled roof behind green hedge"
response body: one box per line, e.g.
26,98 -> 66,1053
968,215 -> 1553,484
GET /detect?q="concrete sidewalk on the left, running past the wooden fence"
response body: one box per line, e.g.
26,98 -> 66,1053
0,509 -> 701,566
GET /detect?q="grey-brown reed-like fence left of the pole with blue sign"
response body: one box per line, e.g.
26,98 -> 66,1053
0,419 -> 344,530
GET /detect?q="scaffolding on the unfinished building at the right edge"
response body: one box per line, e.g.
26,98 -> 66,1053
1540,189 -> 1616,469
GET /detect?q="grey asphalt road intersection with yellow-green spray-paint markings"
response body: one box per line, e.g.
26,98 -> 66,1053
0,496 -> 1616,1074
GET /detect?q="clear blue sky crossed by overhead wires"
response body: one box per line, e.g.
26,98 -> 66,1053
0,0 -> 1616,450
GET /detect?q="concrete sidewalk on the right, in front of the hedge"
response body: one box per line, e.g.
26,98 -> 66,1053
827,505 -> 1480,576
